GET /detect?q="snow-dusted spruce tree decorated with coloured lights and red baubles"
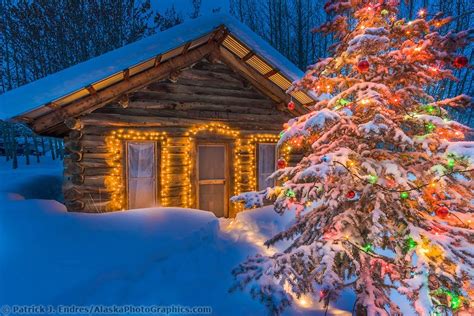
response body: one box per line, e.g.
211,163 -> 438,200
233,0 -> 474,315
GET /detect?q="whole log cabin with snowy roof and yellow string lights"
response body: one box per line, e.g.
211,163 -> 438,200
0,15 -> 316,217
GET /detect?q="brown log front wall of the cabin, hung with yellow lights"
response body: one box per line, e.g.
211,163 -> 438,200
64,60 -> 291,217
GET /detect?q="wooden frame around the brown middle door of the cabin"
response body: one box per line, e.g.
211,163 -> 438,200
194,143 -> 231,217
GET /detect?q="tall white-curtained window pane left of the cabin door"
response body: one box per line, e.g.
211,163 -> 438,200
127,142 -> 157,209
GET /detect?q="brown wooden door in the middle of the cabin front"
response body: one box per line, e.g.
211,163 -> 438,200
197,144 -> 229,217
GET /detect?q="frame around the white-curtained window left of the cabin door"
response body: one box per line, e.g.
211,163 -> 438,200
123,140 -> 161,210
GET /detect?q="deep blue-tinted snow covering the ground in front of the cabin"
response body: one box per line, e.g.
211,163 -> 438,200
0,158 -> 353,315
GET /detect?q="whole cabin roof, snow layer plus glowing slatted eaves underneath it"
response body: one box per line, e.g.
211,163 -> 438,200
0,15 -> 315,135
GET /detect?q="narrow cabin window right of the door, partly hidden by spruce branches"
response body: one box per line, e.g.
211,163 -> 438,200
257,143 -> 276,191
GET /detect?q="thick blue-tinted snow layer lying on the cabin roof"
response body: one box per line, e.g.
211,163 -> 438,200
0,14 -> 314,119
